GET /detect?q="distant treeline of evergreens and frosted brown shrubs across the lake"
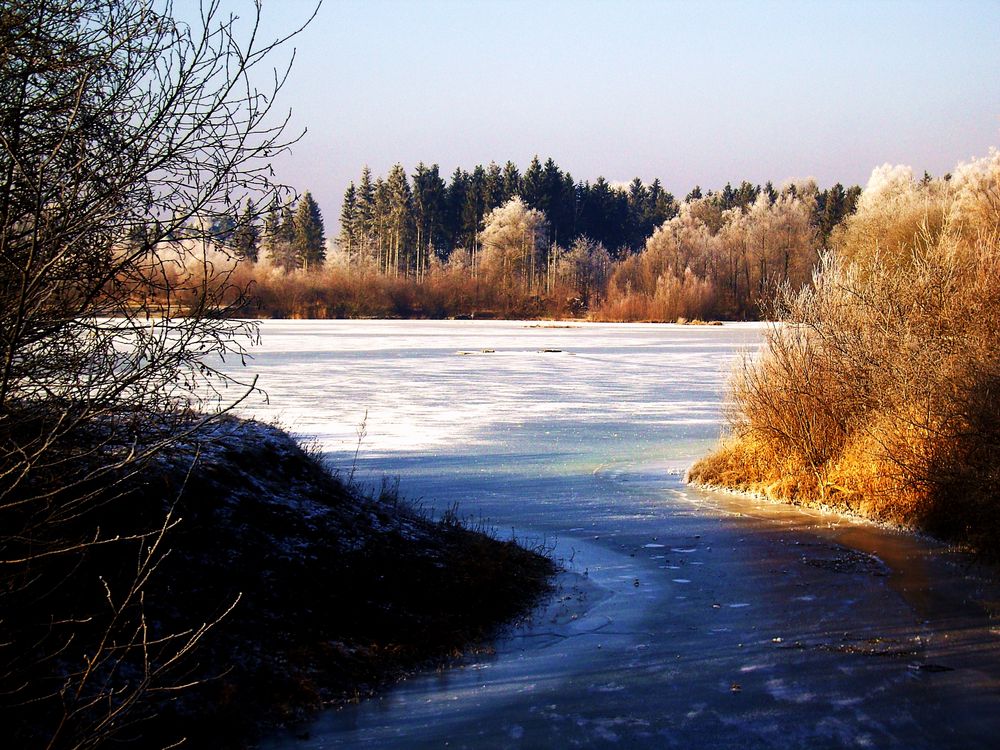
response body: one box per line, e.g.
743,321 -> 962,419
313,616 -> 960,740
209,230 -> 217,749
227,157 -> 861,320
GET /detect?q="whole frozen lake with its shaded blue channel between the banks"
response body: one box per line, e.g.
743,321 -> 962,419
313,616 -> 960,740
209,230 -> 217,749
236,321 -> 1000,749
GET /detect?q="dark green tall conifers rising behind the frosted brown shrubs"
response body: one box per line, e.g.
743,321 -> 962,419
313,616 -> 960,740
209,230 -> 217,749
338,156 -> 860,276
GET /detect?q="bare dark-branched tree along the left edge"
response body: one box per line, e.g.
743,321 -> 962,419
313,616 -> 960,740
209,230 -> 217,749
0,0 -> 316,747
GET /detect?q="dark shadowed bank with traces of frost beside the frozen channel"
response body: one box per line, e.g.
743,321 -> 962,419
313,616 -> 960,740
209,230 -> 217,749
2,420 -> 553,747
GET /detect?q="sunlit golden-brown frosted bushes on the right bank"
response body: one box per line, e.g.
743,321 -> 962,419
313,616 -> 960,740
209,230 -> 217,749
689,151 -> 1000,556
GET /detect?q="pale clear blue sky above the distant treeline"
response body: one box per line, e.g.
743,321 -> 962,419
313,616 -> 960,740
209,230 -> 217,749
177,0 -> 1000,226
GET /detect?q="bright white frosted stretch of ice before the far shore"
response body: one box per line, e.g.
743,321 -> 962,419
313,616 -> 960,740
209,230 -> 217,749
230,321 -> 757,458
